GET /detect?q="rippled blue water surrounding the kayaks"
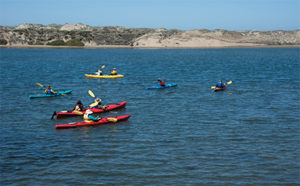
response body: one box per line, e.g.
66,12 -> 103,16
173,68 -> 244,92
0,48 -> 300,185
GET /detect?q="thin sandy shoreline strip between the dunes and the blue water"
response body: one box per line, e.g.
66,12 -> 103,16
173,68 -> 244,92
0,45 -> 300,49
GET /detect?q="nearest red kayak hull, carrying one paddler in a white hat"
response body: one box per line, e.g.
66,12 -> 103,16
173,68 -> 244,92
55,114 -> 131,129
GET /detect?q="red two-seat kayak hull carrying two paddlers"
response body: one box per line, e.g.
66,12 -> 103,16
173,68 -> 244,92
56,101 -> 127,119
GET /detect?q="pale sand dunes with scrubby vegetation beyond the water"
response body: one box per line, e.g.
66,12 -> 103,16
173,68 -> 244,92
0,23 -> 300,47
